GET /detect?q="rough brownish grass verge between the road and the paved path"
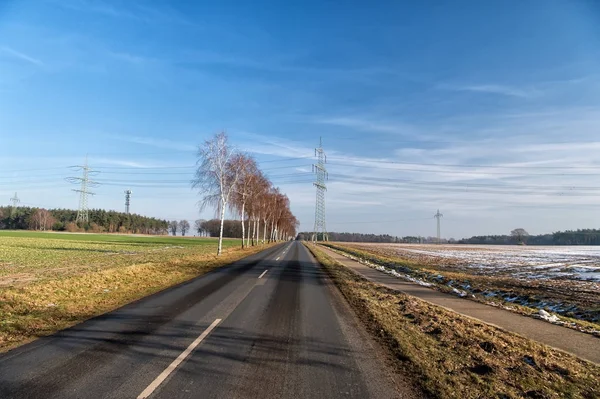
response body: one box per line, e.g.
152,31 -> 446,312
307,244 -> 600,399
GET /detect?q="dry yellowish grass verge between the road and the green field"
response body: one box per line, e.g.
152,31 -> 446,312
0,245 -> 270,352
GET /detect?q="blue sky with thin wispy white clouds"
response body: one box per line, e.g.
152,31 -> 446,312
0,0 -> 600,238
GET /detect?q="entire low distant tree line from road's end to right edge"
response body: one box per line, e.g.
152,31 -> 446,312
298,229 -> 600,245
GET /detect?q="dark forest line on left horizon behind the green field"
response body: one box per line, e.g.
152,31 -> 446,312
0,206 -> 168,234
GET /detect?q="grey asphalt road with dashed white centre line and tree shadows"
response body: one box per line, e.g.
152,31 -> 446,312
0,242 -> 420,399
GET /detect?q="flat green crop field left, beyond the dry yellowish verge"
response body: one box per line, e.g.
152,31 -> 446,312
0,231 -> 241,286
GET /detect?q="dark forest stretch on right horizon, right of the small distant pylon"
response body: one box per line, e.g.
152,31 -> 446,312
458,229 -> 600,245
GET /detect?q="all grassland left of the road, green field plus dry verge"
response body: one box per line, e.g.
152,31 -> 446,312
0,231 -> 255,351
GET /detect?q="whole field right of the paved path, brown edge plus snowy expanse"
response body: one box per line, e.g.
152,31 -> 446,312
331,243 -> 600,335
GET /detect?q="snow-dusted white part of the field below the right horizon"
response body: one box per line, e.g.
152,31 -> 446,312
360,244 -> 600,282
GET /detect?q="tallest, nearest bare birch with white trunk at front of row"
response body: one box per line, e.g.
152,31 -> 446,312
192,132 -> 240,255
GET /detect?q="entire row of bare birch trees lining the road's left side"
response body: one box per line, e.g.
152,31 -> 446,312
192,133 -> 299,255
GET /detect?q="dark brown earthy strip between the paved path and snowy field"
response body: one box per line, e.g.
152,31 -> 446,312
327,244 -> 600,337
